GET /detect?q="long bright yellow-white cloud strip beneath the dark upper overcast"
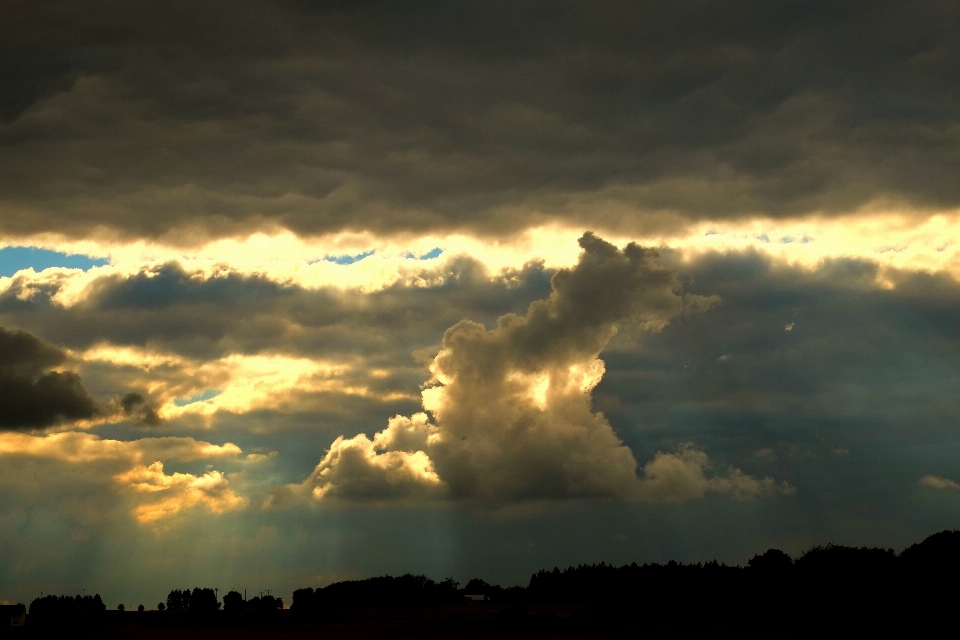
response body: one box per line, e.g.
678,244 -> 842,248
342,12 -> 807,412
7,209 -> 960,307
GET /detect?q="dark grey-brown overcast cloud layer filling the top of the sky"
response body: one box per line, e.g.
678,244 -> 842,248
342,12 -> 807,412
0,1 -> 960,241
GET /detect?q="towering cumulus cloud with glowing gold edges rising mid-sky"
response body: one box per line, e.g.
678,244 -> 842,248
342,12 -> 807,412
275,233 -> 785,501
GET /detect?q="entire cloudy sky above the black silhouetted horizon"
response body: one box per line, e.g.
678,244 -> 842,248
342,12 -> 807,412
0,0 -> 960,608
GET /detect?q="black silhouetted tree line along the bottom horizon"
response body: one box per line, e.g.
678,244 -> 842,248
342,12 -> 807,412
22,531 -> 960,635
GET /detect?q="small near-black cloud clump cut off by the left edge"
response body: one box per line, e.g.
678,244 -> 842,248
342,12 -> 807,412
0,327 -> 98,430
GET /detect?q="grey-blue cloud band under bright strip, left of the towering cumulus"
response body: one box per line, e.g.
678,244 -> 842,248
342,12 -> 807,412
0,255 -> 549,364
